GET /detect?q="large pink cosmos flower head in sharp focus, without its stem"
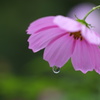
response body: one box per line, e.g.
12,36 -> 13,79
27,15 -> 100,73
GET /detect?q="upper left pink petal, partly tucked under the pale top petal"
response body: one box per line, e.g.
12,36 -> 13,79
27,16 -> 55,34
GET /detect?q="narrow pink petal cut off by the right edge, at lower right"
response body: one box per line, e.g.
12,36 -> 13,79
94,46 -> 100,74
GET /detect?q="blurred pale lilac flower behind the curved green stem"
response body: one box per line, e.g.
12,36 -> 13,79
67,3 -> 100,33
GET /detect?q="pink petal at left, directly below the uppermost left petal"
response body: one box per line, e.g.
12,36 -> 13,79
28,28 -> 66,52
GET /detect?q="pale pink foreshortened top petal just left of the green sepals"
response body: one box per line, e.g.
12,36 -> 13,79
54,15 -> 81,32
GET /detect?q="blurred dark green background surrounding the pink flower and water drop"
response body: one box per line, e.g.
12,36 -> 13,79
0,0 -> 100,100
